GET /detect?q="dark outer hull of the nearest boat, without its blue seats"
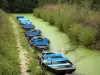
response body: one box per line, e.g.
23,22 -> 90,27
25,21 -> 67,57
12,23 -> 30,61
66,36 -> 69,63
39,51 -> 76,75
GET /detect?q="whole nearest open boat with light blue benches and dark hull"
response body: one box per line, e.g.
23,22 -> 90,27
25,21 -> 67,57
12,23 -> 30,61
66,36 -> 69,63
40,52 -> 76,74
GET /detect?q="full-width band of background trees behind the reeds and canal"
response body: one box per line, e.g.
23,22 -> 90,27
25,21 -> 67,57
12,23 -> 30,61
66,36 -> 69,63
0,0 -> 100,12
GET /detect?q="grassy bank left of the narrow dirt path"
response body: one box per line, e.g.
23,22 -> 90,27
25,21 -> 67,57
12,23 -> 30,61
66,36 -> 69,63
0,10 -> 20,75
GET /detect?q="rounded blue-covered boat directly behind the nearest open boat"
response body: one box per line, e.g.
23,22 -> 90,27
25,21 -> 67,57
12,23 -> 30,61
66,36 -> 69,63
30,36 -> 50,51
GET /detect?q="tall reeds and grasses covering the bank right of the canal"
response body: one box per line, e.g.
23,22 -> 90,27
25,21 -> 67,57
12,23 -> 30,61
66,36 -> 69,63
34,4 -> 100,49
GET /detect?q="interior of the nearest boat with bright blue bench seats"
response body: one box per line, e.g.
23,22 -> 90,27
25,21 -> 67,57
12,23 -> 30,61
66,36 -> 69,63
42,53 -> 72,69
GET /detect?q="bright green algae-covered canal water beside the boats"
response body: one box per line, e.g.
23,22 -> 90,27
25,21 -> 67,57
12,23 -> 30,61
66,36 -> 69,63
13,14 -> 100,75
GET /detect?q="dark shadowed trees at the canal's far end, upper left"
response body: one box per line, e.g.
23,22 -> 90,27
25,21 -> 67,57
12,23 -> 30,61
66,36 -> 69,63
0,0 -> 38,12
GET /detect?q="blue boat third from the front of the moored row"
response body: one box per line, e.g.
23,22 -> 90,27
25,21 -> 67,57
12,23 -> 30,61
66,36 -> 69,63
25,29 -> 41,40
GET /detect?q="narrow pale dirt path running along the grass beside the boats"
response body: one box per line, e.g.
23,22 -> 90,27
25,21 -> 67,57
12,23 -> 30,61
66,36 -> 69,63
10,17 -> 29,75
